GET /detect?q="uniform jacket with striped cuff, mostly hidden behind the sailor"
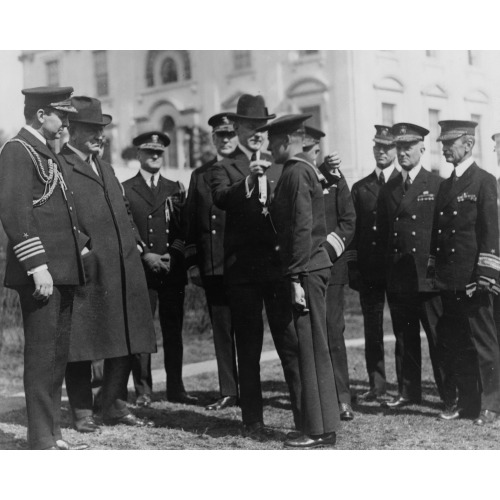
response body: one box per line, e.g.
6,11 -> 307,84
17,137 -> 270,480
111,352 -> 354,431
319,166 -> 356,285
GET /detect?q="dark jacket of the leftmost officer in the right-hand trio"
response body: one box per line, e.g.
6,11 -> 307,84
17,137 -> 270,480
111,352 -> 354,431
350,169 -> 399,284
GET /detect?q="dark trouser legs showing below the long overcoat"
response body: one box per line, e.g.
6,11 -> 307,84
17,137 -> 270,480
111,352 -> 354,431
66,356 -> 132,420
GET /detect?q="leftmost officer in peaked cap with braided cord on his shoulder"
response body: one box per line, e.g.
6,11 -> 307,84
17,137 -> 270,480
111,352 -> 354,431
0,87 -> 88,450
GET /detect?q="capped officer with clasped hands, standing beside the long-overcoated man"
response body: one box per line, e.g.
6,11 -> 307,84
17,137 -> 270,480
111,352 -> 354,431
123,131 -> 197,405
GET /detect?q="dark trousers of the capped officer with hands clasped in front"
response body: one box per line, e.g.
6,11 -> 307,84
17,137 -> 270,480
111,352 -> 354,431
132,285 -> 185,397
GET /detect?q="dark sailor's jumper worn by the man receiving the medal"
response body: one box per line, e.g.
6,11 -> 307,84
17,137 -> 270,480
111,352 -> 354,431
271,153 -> 332,277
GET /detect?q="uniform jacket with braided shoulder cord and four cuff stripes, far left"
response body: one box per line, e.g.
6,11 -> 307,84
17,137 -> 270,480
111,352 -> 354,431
0,128 -> 88,287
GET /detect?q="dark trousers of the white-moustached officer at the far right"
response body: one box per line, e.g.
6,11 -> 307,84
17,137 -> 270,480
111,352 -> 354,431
438,292 -> 500,413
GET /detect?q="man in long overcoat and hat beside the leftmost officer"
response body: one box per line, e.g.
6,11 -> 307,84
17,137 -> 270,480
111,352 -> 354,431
60,96 -> 156,432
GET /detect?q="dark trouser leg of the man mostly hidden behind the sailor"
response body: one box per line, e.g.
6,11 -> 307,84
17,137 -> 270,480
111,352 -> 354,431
326,284 -> 351,404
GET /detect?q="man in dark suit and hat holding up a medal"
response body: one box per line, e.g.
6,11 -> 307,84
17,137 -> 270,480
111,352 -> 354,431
211,94 -> 300,437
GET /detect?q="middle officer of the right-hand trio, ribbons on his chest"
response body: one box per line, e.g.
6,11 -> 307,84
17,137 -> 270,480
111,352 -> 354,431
377,123 -> 446,409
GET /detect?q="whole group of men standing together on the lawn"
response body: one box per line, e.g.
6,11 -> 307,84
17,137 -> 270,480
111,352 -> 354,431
0,87 -> 500,450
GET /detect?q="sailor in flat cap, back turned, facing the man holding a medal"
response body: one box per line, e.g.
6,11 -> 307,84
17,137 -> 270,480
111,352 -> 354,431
266,115 -> 340,449
